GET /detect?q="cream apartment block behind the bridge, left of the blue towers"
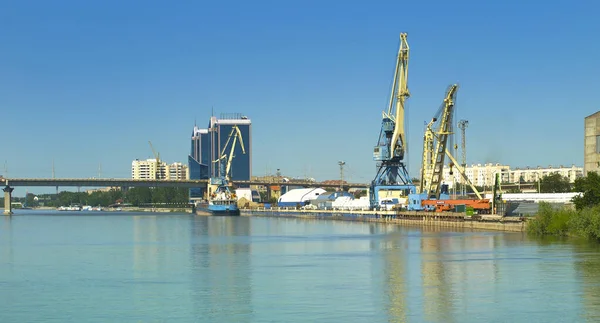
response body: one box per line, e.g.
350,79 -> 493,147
131,158 -> 188,180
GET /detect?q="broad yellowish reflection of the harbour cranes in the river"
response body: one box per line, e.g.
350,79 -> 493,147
376,225 -> 525,322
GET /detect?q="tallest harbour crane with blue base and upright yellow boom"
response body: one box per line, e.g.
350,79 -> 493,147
369,33 -> 416,208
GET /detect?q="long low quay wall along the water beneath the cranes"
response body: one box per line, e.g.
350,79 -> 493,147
240,208 -> 527,232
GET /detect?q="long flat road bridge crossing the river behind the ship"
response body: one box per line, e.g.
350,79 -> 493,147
0,177 -> 369,215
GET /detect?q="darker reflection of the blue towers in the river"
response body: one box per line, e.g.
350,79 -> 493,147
190,217 -> 253,322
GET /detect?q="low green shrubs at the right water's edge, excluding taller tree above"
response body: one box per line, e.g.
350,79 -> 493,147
527,203 -> 600,241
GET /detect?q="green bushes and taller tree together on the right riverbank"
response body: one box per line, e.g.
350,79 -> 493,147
527,172 -> 600,241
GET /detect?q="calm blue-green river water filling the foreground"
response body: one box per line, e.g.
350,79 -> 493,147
0,210 -> 600,323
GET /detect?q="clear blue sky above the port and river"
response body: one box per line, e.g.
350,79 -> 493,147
0,0 -> 600,195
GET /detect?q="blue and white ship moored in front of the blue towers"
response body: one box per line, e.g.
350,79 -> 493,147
196,178 -> 240,216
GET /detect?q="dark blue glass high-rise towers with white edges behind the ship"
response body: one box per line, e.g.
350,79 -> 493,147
188,113 -> 252,199
